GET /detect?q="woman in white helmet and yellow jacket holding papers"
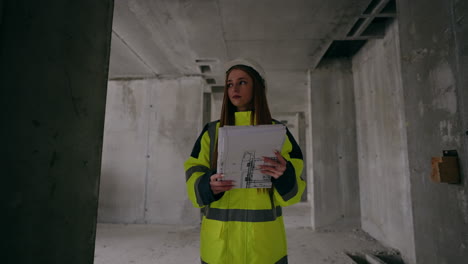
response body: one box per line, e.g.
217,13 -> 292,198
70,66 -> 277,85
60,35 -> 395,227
184,59 -> 305,264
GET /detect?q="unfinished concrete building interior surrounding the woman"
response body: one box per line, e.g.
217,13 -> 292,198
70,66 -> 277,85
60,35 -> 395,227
0,0 -> 468,264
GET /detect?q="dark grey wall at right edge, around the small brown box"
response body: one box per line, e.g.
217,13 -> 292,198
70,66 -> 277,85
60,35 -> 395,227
397,0 -> 468,264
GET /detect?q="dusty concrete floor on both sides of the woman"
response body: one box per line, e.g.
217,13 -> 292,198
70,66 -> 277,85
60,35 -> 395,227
94,203 -> 390,264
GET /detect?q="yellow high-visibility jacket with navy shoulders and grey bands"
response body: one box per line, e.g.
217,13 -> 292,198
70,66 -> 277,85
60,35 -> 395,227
184,111 -> 305,264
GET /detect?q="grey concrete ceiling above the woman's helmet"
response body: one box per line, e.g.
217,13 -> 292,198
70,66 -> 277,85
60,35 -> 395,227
110,0 -> 370,85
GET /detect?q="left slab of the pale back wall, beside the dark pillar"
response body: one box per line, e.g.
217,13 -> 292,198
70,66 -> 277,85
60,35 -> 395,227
98,81 -> 150,223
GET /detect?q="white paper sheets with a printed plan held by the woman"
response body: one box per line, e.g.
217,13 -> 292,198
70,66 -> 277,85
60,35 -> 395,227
217,124 -> 286,188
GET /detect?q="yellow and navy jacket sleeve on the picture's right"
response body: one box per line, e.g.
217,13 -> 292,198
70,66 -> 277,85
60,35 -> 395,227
272,128 -> 306,206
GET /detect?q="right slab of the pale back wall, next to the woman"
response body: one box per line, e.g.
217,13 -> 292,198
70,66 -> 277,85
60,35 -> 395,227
146,77 -> 204,224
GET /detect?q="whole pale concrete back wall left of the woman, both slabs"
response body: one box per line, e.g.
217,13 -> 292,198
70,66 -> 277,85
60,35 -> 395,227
99,77 -> 203,224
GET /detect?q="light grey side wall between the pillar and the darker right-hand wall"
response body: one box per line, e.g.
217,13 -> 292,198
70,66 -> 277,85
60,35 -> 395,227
352,23 -> 415,263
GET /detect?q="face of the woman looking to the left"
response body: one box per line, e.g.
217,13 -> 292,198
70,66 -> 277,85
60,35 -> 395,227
226,69 -> 253,111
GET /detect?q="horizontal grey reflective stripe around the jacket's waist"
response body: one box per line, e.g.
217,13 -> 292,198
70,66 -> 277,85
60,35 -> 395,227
205,206 -> 283,222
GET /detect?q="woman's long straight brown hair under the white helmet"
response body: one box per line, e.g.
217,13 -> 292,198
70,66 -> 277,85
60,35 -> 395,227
211,65 -> 272,190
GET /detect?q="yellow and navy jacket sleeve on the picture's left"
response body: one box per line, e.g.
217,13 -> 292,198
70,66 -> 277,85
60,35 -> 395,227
184,124 -> 222,208
